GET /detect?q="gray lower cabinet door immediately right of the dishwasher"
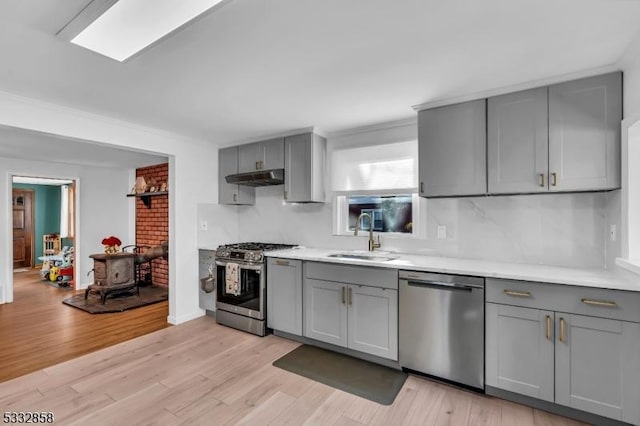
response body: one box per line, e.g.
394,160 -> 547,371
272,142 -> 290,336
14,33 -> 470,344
486,303 -> 554,402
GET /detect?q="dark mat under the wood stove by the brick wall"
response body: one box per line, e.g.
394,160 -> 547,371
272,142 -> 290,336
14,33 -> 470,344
62,287 -> 169,314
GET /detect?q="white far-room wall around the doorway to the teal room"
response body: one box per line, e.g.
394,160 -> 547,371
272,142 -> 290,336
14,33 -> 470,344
0,156 -> 134,301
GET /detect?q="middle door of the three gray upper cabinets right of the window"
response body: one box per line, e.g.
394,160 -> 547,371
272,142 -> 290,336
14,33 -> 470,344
487,87 -> 549,194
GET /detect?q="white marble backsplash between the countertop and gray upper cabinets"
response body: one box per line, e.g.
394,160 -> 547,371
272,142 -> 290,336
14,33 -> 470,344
218,186 -> 608,268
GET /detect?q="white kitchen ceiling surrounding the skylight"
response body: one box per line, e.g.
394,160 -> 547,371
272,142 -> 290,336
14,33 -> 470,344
0,0 -> 640,144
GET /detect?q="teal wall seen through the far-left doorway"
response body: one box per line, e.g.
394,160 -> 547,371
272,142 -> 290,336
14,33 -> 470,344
13,183 -> 60,264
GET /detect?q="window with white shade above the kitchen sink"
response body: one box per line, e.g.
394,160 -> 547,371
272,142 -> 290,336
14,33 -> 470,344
330,140 -> 419,236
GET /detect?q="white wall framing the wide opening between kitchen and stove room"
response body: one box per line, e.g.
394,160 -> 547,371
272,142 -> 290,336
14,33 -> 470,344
0,92 -> 218,324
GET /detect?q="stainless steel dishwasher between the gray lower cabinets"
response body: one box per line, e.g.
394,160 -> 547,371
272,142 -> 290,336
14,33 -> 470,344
398,271 -> 484,392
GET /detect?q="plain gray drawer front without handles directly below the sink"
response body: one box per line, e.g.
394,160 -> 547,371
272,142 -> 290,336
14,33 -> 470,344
305,262 -> 398,290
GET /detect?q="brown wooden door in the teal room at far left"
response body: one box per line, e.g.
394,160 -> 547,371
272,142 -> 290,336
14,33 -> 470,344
11,189 -> 33,268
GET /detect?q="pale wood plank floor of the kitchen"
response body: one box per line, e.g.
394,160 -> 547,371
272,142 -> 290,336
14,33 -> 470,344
0,317 -> 580,426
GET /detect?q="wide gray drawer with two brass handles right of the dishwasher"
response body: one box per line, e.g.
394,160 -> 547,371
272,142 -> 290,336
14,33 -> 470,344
486,278 -> 640,322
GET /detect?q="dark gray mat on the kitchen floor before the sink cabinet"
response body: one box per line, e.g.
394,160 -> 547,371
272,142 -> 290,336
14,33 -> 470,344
273,345 -> 407,405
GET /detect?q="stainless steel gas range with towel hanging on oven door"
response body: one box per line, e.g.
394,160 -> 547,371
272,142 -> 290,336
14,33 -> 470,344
215,243 -> 294,336
